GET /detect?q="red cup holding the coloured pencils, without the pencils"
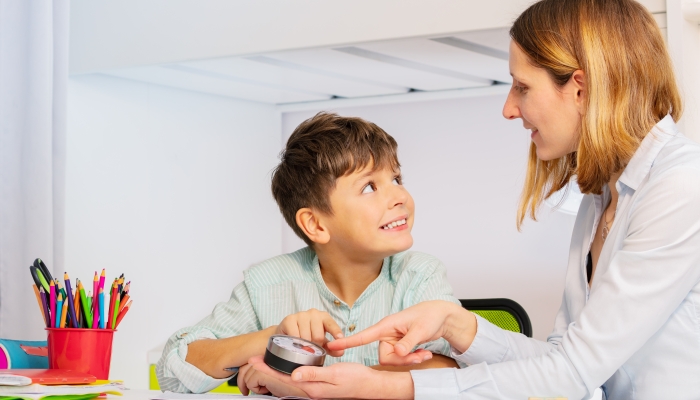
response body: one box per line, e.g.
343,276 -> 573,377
46,328 -> 116,379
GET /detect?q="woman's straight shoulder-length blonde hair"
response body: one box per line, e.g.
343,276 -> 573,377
510,0 -> 682,229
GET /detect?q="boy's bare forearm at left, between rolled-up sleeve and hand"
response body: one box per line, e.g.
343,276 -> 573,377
185,326 -> 277,379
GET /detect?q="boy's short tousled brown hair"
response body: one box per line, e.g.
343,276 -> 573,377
272,112 -> 400,246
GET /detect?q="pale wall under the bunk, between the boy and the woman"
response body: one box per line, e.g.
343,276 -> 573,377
282,95 -> 574,339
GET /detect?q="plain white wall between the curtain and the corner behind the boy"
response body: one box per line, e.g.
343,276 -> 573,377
65,76 -> 281,388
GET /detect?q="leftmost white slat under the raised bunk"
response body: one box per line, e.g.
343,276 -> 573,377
105,65 -> 330,104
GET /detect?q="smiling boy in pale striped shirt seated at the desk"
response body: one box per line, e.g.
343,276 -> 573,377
156,113 -> 459,393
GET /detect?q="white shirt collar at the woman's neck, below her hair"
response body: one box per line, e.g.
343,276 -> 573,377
618,115 -> 678,190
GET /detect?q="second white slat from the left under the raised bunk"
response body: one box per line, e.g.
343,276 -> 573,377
180,56 -> 408,97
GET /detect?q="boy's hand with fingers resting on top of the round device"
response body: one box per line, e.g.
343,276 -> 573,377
275,308 -> 345,357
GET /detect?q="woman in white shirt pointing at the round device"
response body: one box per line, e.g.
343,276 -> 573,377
238,0 -> 700,399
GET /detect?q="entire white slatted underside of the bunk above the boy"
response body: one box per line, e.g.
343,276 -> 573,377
101,28 -> 510,104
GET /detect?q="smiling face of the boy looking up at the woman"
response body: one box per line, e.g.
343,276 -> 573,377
324,164 -> 414,261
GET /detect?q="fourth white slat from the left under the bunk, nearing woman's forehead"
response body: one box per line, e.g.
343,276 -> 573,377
357,39 -> 511,83
